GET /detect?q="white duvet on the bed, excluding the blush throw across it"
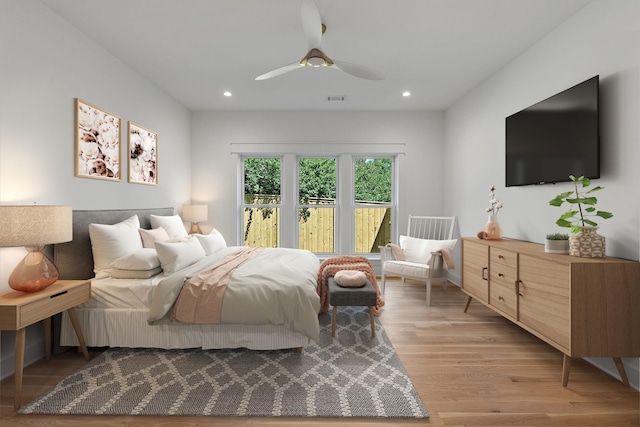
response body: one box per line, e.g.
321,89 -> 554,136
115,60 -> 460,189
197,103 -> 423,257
148,247 -> 320,341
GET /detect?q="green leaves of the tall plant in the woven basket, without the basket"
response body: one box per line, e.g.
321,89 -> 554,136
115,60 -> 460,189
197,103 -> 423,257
549,175 -> 613,234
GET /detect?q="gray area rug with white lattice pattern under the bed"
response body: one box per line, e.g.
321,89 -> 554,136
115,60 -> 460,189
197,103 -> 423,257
18,307 -> 428,418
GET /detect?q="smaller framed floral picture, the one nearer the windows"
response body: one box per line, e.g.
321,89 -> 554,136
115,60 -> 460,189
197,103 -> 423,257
128,121 -> 158,185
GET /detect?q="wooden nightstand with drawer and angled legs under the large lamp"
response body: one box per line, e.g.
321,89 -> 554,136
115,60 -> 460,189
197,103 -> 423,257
0,280 -> 91,410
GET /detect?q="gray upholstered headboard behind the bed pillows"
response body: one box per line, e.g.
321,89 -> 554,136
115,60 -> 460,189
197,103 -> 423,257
53,208 -> 173,280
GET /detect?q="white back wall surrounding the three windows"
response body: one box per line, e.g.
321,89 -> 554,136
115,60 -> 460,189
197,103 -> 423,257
191,111 -> 449,244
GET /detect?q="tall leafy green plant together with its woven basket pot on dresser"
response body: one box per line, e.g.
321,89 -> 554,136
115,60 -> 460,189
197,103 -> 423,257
549,175 -> 613,258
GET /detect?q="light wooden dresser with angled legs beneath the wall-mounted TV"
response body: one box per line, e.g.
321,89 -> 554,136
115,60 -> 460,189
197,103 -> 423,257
462,237 -> 640,386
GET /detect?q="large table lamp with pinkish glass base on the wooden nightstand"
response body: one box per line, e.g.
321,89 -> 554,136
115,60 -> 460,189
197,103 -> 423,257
0,205 -> 73,292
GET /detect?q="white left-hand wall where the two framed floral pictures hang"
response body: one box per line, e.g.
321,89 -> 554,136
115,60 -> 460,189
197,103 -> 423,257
0,0 -> 191,377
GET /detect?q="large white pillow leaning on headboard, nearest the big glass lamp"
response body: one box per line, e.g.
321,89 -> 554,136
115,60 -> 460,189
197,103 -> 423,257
89,215 -> 142,279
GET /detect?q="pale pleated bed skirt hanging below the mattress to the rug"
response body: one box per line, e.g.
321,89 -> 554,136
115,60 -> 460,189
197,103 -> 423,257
60,308 -> 311,350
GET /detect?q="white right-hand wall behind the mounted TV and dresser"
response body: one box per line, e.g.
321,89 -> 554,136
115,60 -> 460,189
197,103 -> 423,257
445,0 -> 640,388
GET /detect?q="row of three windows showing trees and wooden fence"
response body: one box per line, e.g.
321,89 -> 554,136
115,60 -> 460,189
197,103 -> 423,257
240,154 -> 396,256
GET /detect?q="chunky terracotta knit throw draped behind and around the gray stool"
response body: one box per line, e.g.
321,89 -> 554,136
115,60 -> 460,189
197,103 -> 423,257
317,255 -> 384,316
